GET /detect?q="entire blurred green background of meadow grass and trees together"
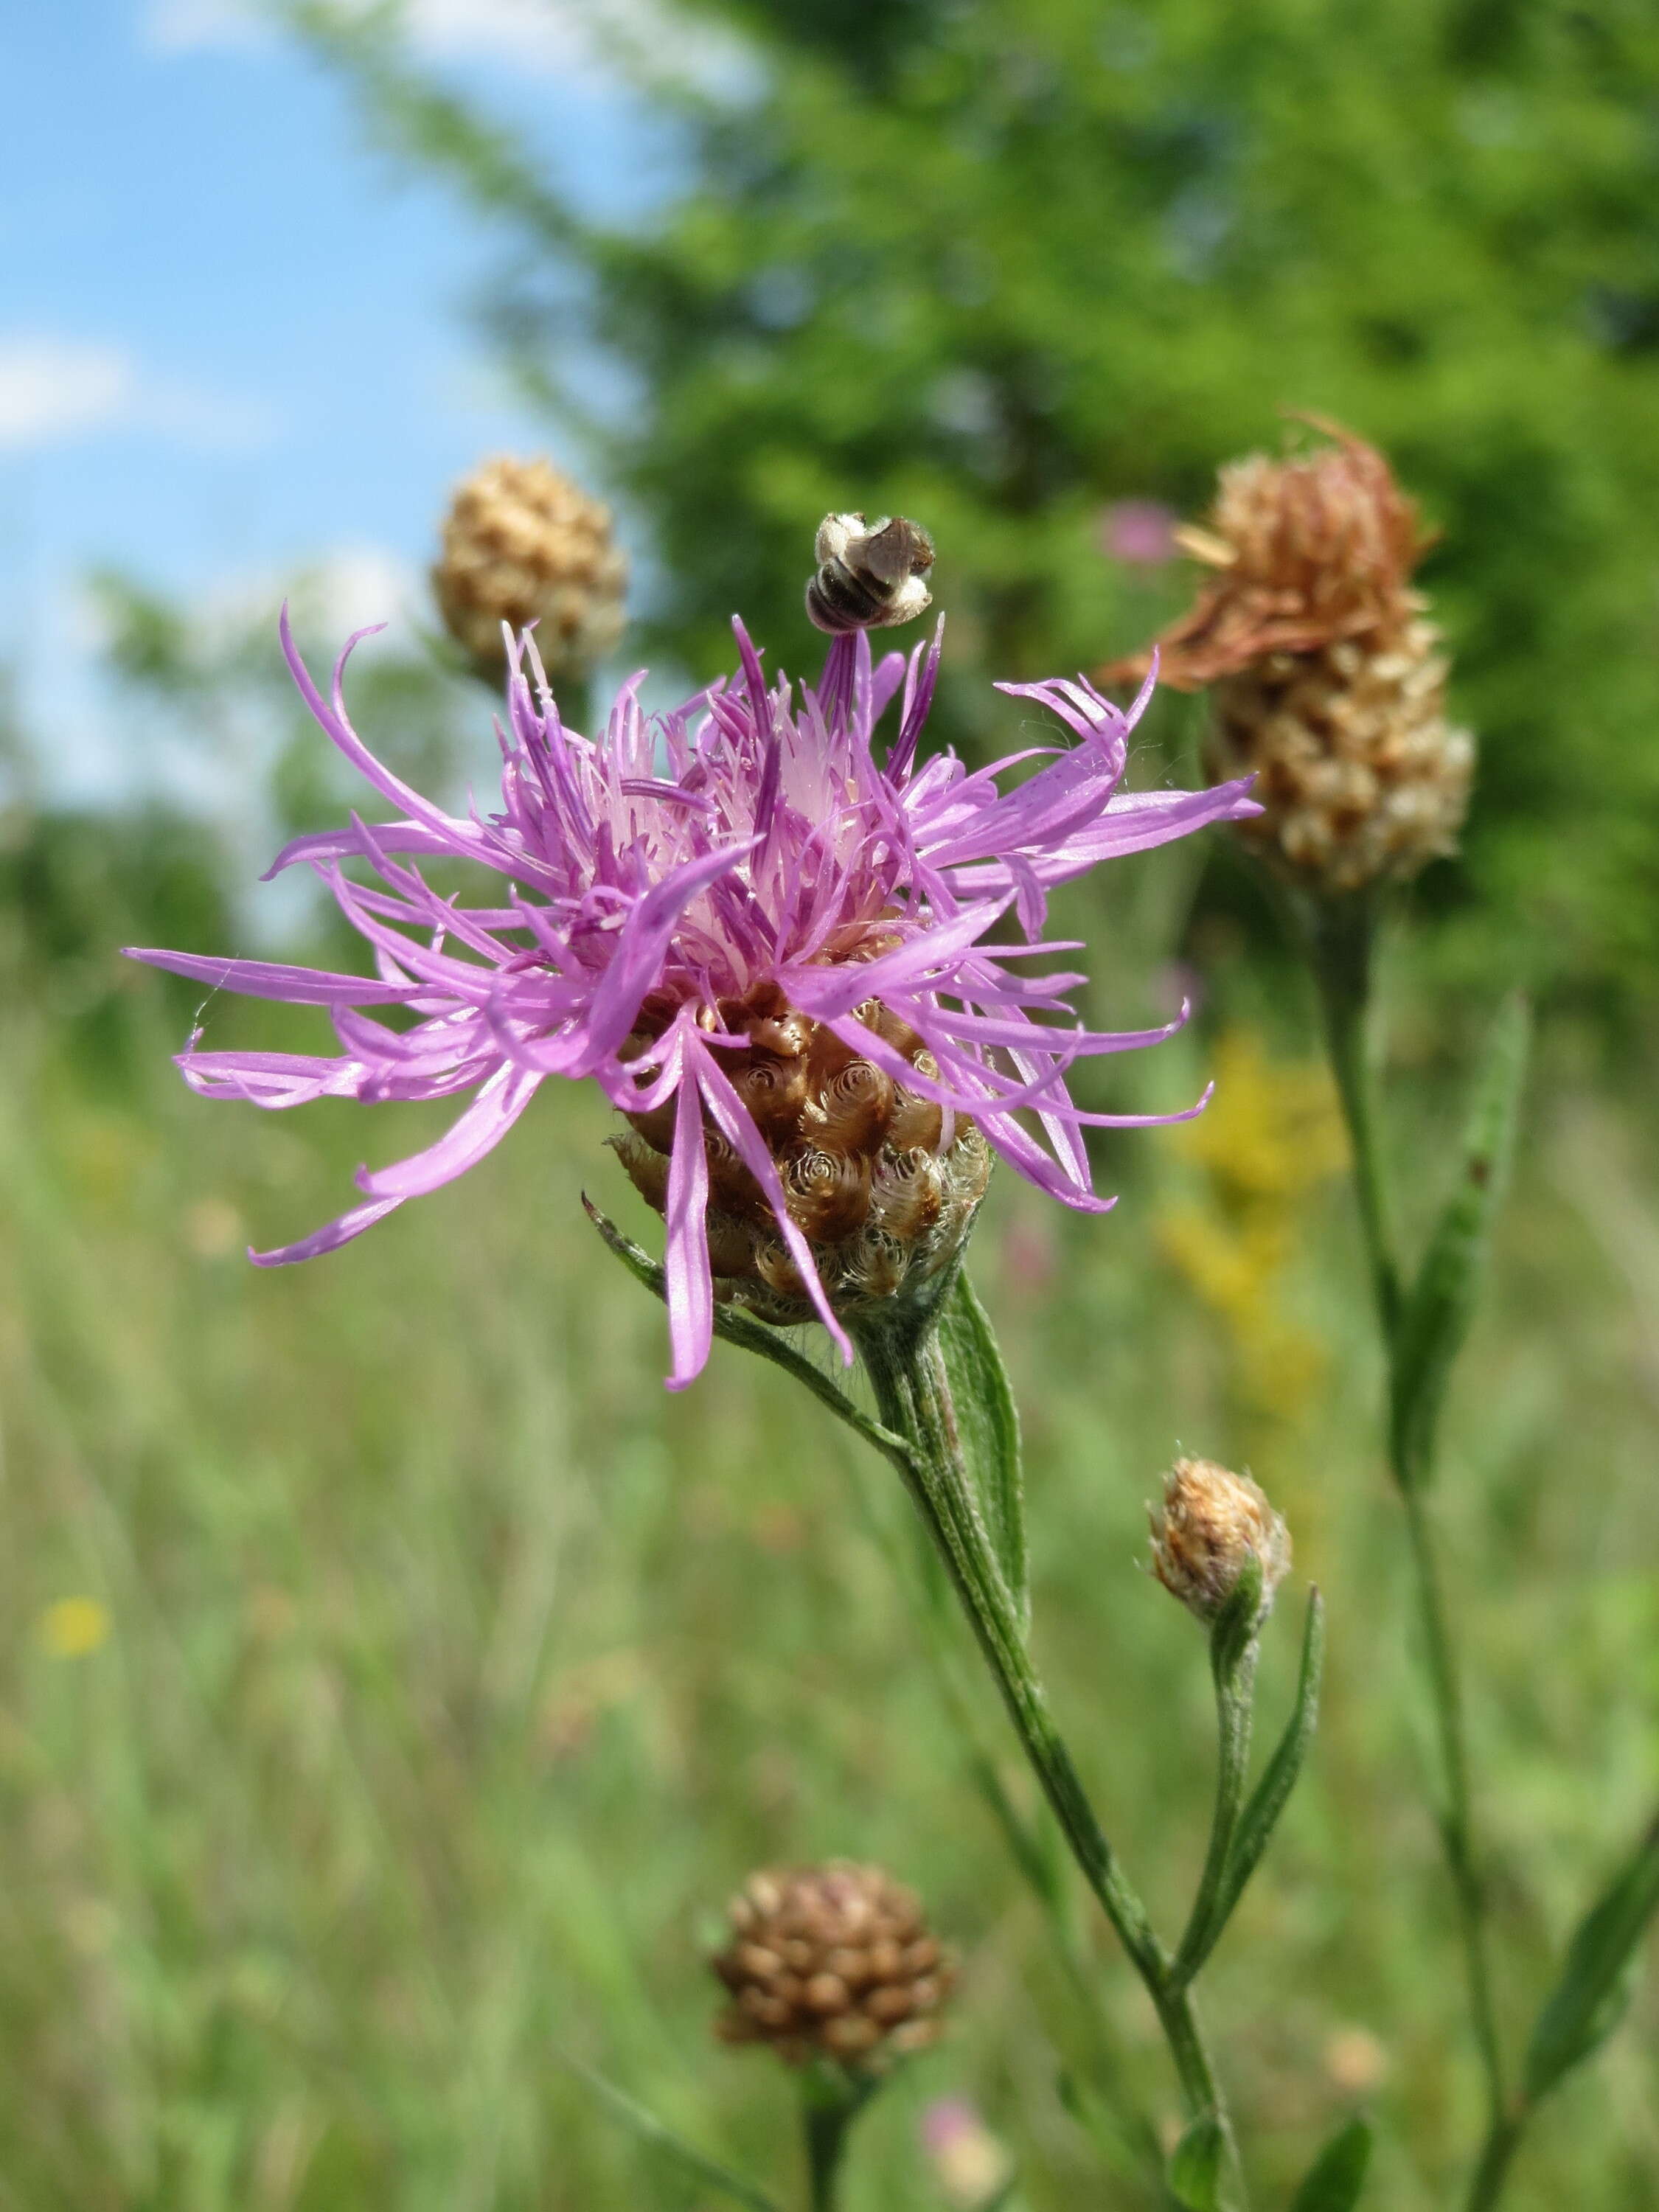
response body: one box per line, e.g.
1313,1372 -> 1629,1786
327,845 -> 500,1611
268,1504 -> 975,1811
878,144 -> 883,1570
0,0 -> 1659,2212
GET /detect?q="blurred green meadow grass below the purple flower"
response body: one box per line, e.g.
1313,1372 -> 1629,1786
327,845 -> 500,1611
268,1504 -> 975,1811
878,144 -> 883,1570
0,902 -> 1659,2212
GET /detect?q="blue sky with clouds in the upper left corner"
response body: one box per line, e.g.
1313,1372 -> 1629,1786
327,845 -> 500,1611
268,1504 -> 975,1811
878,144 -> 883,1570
0,0 -> 703,787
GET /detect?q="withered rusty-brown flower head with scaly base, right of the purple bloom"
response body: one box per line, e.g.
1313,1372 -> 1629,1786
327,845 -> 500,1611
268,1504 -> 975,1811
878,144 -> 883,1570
1106,418 -> 1475,894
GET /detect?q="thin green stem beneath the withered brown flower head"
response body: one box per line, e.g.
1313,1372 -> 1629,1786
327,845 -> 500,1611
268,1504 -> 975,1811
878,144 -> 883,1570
1303,898 -> 1517,2141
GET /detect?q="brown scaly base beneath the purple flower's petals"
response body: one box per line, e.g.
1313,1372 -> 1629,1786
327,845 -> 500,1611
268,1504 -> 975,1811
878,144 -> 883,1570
611,982 -> 991,1325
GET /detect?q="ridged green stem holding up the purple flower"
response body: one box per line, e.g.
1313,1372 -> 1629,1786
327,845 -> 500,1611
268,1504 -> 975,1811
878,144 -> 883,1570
860,1329 -> 1243,2199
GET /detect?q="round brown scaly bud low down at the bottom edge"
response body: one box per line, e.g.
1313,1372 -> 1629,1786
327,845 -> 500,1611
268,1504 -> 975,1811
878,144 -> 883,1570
710,1860 -> 953,2073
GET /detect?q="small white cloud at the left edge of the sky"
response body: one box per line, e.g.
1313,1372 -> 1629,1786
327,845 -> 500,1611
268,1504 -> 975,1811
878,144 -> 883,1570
0,332 -> 276,451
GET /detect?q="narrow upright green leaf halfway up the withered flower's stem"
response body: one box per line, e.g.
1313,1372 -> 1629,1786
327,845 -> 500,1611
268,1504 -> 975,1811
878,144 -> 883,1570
1391,993 -> 1531,1489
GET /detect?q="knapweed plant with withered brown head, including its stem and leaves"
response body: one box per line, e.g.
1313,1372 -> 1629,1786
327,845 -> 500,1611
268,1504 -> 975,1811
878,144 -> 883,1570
1119,418 -> 1659,2212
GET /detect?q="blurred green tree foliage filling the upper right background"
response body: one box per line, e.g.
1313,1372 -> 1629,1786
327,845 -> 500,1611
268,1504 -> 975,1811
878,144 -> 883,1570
283,0 -> 1659,1002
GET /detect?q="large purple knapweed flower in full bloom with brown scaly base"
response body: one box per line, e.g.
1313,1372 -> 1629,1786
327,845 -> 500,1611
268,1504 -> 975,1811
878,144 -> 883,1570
133,615 -> 1254,1387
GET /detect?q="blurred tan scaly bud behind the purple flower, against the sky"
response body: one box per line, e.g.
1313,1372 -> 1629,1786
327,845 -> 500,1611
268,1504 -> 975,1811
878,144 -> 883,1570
431,456 -> 628,684
